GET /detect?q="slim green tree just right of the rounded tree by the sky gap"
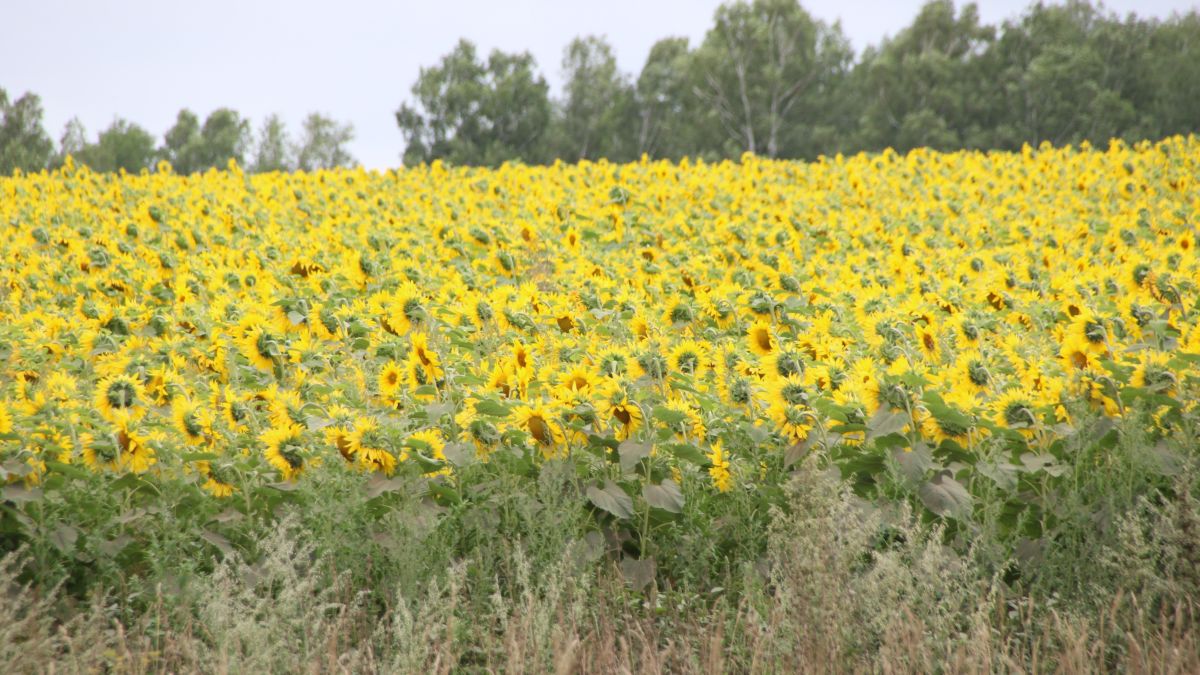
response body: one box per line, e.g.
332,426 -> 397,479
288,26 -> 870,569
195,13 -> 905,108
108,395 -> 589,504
557,36 -> 636,161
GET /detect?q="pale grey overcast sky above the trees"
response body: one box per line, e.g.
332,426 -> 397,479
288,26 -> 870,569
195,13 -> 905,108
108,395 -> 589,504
0,0 -> 1196,168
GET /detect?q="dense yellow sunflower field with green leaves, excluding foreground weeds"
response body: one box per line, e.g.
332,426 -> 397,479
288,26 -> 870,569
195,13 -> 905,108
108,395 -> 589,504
0,137 -> 1200,672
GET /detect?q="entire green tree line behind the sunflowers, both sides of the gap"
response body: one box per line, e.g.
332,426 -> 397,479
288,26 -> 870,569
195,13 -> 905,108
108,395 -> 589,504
0,0 -> 1200,173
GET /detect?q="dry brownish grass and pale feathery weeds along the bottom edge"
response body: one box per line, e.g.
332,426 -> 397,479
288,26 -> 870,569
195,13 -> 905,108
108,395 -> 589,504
0,472 -> 1200,674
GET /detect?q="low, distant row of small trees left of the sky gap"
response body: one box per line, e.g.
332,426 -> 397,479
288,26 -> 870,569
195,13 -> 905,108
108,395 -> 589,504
0,100 -> 355,175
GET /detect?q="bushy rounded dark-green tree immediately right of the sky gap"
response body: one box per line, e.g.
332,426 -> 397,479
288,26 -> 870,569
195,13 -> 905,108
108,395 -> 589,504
396,40 -> 551,166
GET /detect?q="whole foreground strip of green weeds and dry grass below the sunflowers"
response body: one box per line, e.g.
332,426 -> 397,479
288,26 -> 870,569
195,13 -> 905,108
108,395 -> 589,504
0,420 -> 1200,673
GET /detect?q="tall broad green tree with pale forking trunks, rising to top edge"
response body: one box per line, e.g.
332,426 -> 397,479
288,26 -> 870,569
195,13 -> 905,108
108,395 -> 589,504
695,0 -> 852,157
